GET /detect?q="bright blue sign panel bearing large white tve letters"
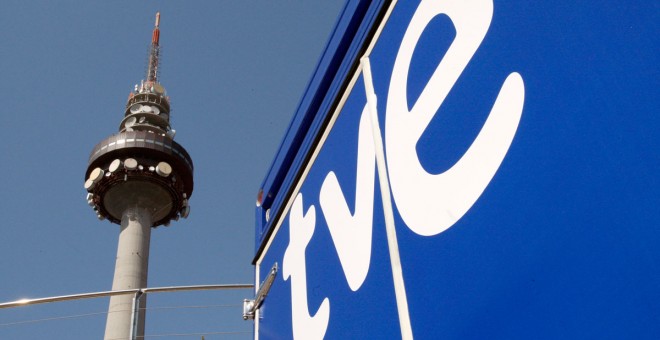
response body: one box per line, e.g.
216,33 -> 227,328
255,0 -> 660,339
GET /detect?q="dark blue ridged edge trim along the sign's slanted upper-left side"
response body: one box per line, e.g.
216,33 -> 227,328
255,0 -> 386,253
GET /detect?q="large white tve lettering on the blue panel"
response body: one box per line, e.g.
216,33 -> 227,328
283,0 -> 525,339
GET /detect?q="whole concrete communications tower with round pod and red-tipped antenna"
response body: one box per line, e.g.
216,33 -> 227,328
85,13 -> 193,339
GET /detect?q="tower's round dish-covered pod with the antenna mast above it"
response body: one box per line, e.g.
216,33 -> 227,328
85,13 -> 194,227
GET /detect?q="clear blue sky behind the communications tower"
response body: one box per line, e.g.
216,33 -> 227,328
0,0 -> 343,340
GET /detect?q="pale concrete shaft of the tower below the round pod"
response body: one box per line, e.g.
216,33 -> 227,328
105,206 -> 152,340
